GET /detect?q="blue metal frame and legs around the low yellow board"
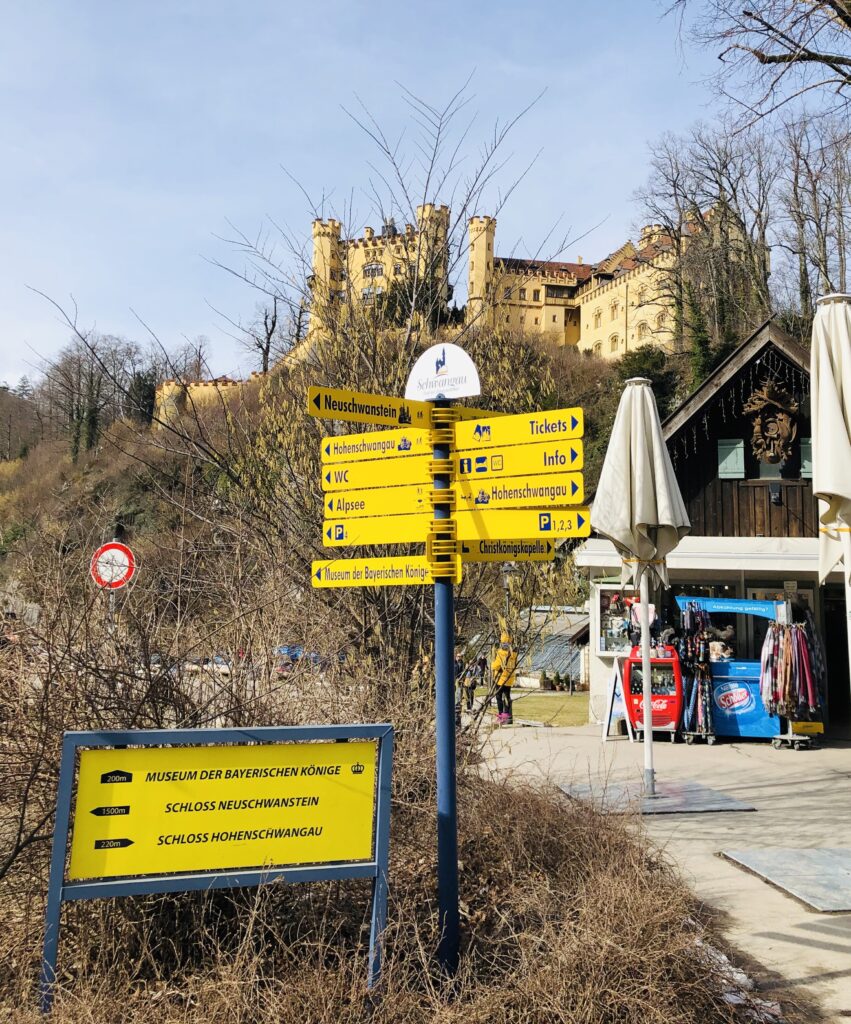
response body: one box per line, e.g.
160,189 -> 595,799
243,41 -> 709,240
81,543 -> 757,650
39,724 -> 393,1014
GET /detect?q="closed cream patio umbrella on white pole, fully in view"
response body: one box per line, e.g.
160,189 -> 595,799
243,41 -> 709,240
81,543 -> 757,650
591,377 -> 691,796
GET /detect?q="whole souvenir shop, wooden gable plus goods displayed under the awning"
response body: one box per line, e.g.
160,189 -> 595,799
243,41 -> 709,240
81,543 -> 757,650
573,323 -> 851,745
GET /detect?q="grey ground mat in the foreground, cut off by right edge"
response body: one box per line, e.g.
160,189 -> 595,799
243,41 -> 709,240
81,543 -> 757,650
722,847 -> 851,912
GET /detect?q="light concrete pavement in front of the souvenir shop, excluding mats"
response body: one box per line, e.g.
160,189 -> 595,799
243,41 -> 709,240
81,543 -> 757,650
486,726 -> 851,1021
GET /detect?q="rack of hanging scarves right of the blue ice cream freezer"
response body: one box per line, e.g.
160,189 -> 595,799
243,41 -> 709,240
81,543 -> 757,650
760,612 -> 826,722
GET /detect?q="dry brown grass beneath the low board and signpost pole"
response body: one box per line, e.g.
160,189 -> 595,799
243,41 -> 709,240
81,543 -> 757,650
0,757 -> 749,1024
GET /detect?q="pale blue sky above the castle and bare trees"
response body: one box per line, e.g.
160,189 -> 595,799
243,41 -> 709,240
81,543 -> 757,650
0,0 -> 714,383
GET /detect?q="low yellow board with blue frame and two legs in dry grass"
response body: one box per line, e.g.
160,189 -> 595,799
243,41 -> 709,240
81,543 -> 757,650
41,725 -> 393,1013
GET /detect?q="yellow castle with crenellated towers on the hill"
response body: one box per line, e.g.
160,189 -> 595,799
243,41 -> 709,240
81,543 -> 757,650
309,205 -> 674,359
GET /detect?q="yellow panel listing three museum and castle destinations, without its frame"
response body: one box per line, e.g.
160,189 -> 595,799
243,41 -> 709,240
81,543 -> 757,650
68,740 -> 377,880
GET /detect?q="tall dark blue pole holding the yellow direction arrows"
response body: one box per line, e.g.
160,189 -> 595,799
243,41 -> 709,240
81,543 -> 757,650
433,401 -> 459,974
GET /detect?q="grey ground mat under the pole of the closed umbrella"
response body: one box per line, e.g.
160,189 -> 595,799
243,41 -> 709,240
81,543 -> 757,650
559,782 -> 756,814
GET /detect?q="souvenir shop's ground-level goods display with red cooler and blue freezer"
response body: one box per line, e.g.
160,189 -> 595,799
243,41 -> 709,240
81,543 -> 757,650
591,557 -> 831,749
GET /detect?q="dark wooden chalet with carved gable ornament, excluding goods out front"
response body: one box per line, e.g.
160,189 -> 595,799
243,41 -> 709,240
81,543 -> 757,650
576,322 -> 851,735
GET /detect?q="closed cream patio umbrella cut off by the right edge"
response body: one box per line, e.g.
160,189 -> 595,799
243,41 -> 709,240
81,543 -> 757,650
810,295 -> 851,666
